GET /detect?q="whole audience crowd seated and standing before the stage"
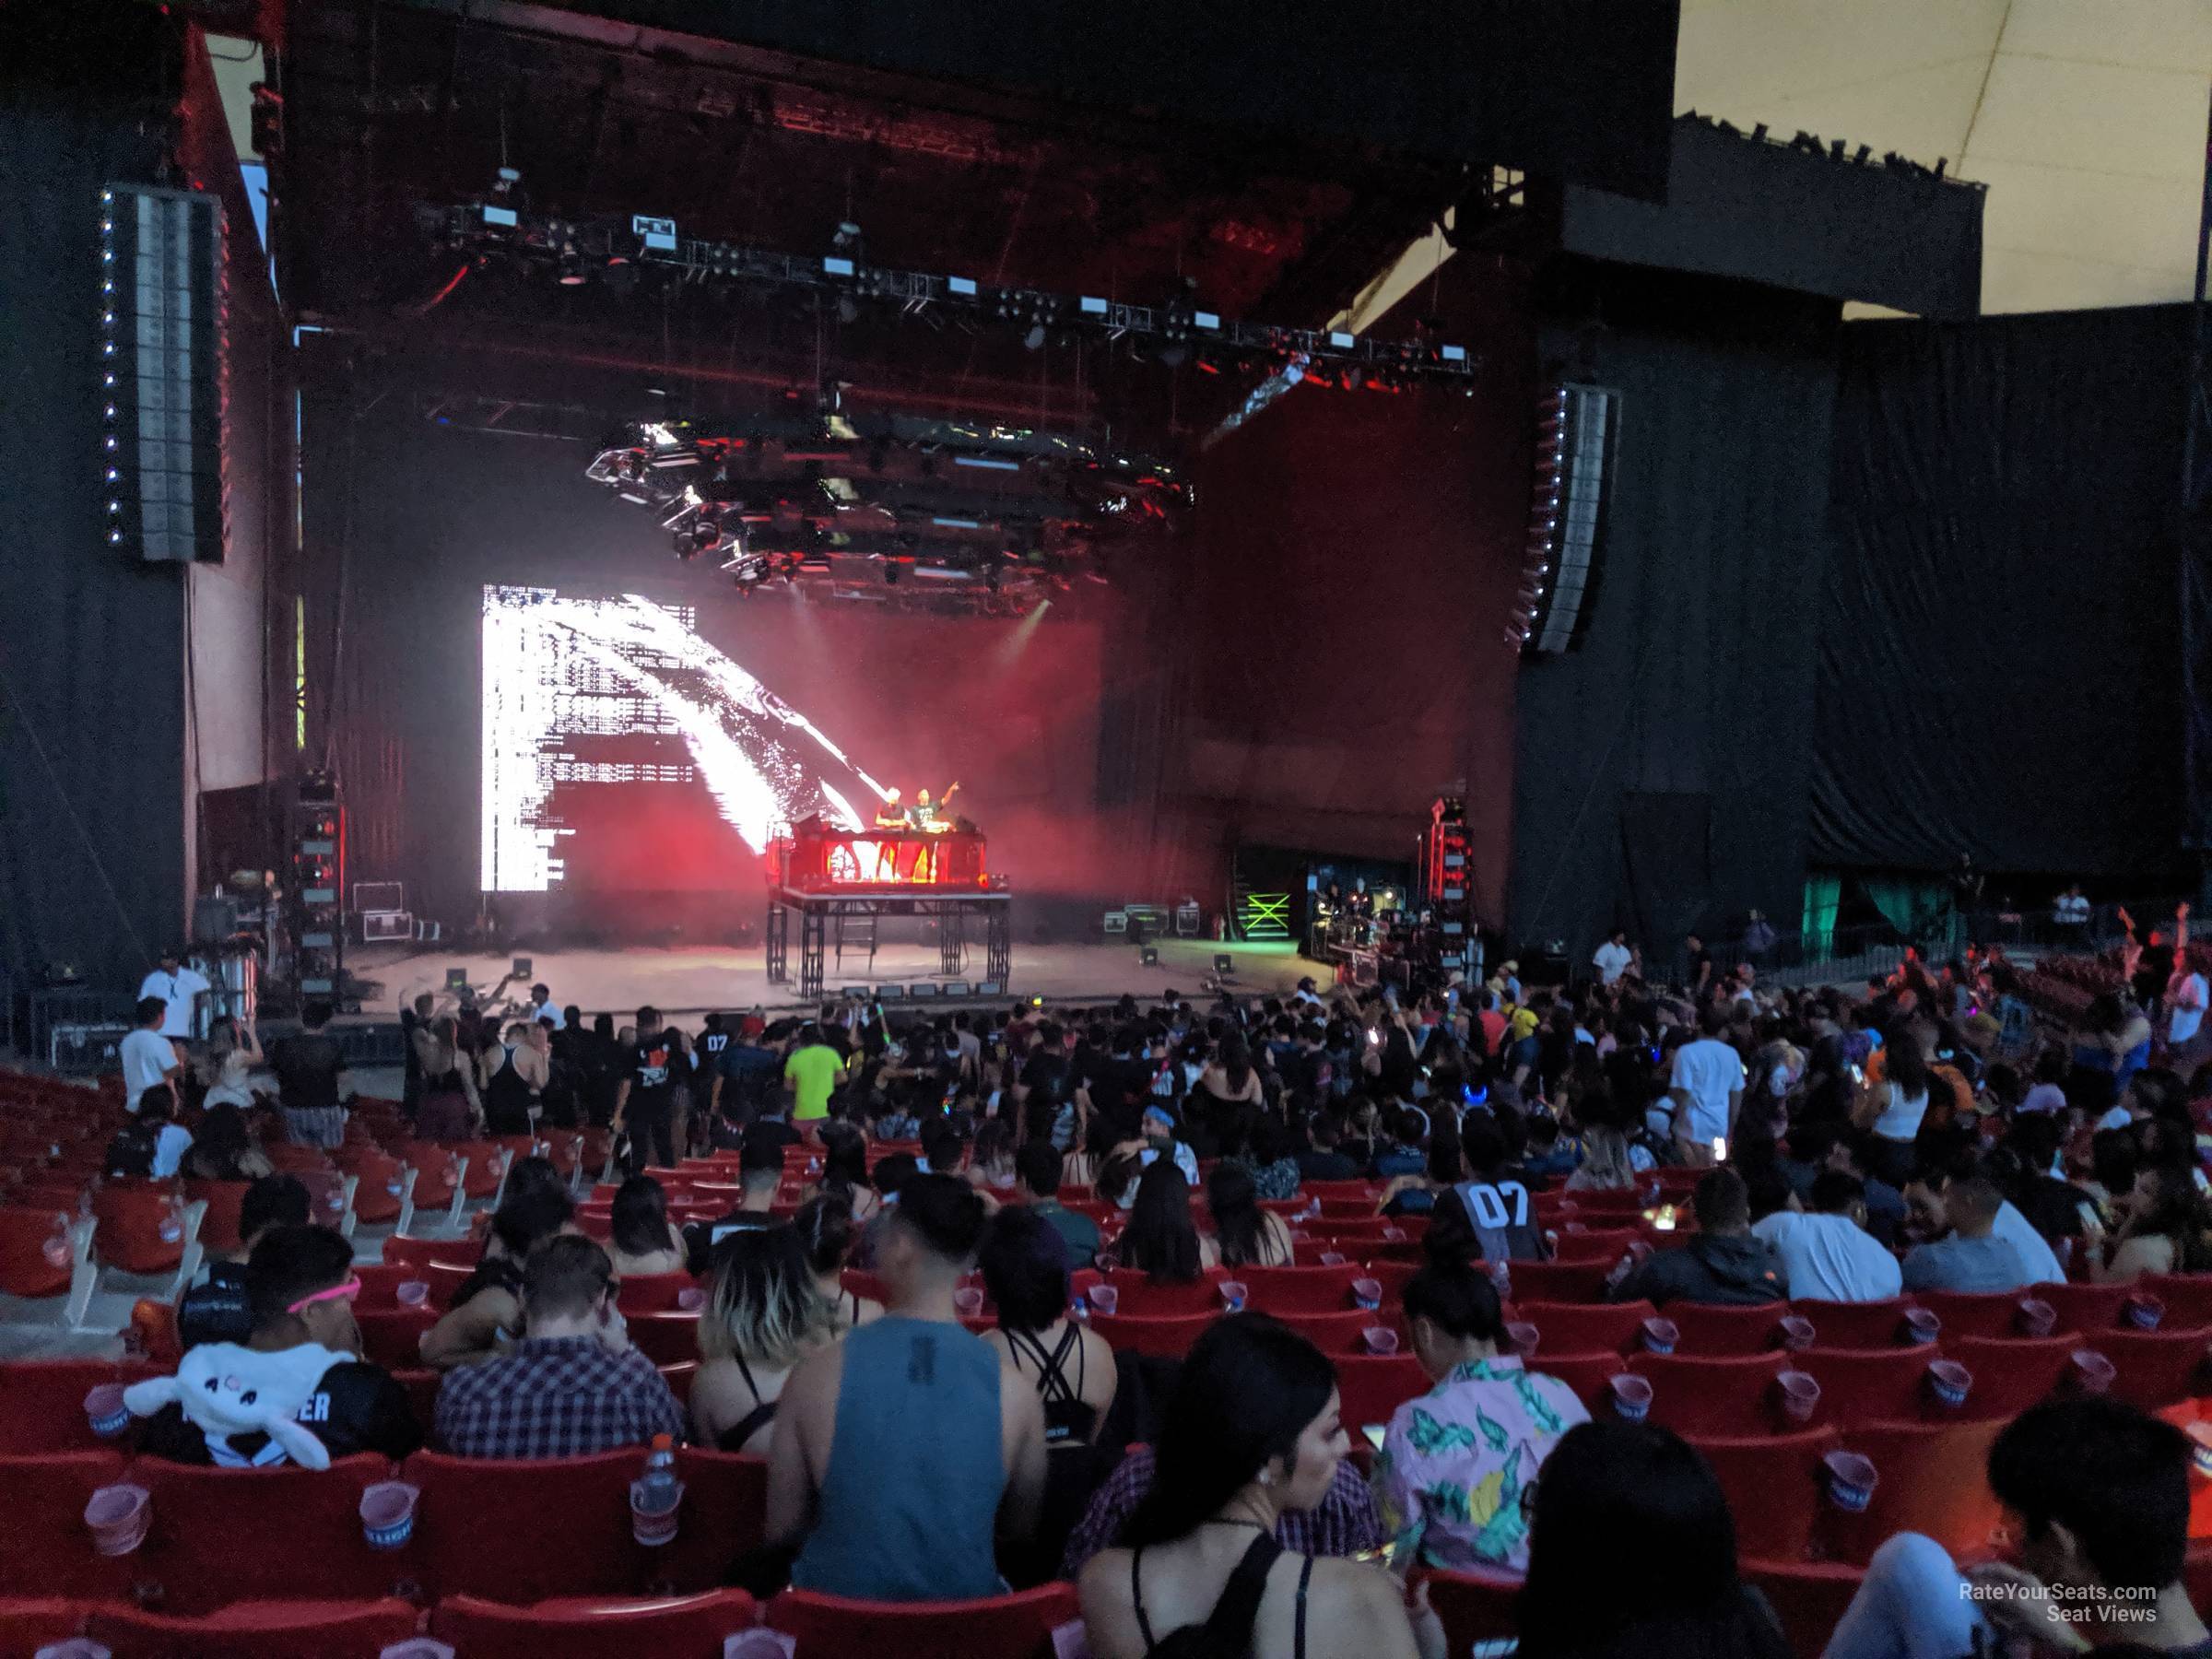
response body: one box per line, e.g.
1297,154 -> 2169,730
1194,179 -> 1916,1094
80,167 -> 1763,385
112,916 -> 2212,1659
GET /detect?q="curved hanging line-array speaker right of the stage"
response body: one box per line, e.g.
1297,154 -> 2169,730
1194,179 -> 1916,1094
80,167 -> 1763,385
1513,385 -> 1621,654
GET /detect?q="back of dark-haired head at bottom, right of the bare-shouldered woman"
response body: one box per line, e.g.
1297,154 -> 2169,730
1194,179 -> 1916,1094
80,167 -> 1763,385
1517,1422 -> 1787,1659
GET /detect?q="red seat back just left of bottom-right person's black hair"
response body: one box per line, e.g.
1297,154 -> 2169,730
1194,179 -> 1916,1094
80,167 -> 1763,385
1820,1416 -> 2004,1566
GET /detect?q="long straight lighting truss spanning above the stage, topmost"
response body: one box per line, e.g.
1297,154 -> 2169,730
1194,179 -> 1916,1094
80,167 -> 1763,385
416,201 -> 1480,382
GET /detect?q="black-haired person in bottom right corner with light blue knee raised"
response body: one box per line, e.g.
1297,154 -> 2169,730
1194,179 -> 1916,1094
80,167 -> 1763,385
1827,1395 -> 2212,1659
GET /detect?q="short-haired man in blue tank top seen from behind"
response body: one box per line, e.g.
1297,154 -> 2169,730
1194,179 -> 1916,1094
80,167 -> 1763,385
768,1174 -> 1046,1602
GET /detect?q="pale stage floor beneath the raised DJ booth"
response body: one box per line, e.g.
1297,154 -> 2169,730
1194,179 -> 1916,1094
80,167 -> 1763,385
345,938 -> 1327,1019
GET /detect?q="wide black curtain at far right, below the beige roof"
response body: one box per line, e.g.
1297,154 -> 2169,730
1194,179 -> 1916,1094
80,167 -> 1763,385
1812,305 -> 2188,878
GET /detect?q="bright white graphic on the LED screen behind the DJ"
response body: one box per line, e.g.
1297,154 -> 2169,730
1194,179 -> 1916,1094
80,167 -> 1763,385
482,586 -> 883,894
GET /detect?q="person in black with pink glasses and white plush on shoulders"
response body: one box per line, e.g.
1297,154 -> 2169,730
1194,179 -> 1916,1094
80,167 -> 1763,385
139,1226 -> 422,1469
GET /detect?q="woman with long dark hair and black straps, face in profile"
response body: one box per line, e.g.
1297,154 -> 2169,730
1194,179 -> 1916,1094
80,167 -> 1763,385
1079,1314 -> 1444,1659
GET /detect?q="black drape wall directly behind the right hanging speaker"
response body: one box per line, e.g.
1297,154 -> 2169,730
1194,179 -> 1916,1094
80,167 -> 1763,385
1509,261 -> 1836,962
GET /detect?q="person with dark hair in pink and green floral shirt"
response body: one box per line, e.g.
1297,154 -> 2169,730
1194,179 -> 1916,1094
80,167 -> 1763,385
1373,1265 -> 1591,1572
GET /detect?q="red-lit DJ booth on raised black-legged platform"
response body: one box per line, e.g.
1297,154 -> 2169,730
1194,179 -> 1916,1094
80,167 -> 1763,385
768,818 -> 1013,1002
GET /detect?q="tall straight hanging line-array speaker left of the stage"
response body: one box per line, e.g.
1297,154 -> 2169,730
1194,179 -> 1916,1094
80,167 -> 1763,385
100,183 -> 230,562
